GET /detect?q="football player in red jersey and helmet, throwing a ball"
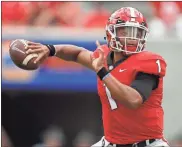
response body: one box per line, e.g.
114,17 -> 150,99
27,7 -> 169,147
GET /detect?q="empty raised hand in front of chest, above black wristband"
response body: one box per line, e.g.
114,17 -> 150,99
91,40 -> 104,73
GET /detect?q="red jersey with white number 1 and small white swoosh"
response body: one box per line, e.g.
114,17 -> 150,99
94,45 -> 166,144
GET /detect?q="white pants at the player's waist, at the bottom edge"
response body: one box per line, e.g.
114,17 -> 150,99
91,136 -> 169,147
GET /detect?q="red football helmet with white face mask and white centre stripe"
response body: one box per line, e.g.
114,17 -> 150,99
106,7 -> 149,55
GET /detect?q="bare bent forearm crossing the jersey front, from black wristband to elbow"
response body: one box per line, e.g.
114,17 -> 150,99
103,74 -> 142,109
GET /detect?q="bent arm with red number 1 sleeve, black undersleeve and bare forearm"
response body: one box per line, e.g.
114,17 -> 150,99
103,59 -> 166,109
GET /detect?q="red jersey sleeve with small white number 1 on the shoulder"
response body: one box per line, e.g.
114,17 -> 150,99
136,57 -> 167,77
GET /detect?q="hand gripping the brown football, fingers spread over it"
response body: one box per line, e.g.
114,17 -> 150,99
26,41 -> 50,63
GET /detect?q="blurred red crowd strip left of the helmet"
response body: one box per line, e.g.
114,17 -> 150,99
2,2 -> 110,27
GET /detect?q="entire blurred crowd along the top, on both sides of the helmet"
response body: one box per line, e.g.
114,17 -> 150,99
2,1 -> 182,38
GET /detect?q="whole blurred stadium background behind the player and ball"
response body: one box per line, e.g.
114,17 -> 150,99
1,2 -> 182,147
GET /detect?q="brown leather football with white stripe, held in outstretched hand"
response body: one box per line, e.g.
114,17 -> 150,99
9,39 -> 39,70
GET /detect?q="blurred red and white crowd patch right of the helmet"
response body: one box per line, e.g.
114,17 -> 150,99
149,1 -> 182,38
